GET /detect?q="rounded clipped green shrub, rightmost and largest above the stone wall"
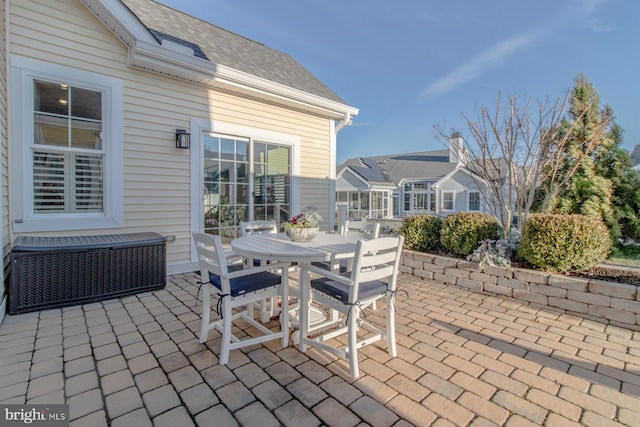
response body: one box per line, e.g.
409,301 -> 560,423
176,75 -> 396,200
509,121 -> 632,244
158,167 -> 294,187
518,214 -> 611,271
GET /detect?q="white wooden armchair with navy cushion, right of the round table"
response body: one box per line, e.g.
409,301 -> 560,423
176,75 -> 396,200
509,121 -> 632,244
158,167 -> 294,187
300,236 -> 404,377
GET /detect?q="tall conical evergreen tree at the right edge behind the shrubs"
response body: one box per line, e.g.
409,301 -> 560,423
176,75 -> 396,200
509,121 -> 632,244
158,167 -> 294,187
538,74 -> 640,243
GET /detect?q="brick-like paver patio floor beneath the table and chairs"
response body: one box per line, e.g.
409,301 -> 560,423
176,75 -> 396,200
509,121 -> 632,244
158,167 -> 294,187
0,273 -> 640,427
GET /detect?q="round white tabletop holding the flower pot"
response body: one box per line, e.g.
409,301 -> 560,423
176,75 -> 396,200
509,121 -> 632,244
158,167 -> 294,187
231,233 -> 358,262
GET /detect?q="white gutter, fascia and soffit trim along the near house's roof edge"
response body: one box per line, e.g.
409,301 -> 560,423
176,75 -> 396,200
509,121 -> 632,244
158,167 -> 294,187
80,0 -> 359,119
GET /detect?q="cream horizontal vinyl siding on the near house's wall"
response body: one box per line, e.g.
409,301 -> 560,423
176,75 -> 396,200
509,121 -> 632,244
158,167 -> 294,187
11,0 -> 331,264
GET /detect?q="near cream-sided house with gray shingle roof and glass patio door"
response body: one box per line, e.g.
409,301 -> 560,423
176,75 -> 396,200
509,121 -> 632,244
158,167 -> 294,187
0,0 -> 358,313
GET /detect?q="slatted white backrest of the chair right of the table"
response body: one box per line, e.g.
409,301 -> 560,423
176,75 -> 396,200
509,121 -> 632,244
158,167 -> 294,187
349,236 -> 404,303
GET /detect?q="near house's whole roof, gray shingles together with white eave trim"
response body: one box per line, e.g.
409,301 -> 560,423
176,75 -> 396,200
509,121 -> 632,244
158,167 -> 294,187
81,0 -> 358,120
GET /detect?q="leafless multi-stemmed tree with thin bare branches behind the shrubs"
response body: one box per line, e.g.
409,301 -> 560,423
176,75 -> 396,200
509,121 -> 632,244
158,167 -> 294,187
434,91 -> 572,236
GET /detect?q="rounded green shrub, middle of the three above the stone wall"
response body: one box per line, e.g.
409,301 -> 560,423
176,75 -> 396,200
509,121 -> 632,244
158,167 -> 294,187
440,212 -> 500,257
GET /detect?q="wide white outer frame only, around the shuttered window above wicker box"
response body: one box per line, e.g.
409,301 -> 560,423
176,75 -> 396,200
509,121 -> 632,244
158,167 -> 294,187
9,55 -> 124,233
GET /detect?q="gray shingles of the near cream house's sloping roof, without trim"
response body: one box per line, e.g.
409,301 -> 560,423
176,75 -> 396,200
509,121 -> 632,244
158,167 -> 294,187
121,0 -> 346,104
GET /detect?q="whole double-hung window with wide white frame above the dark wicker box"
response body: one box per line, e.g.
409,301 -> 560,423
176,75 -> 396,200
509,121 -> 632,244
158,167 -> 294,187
11,56 -> 123,232
